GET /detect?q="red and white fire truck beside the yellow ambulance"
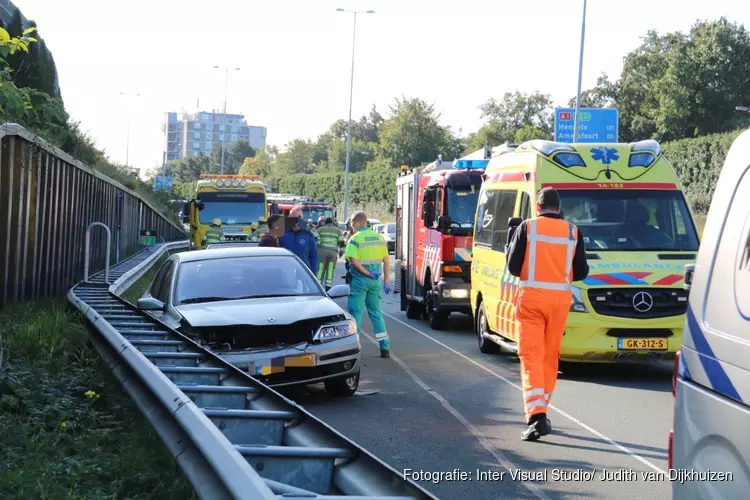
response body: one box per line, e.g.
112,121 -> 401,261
394,154 -> 490,330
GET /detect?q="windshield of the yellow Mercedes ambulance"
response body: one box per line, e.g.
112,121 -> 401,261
558,189 -> 698,252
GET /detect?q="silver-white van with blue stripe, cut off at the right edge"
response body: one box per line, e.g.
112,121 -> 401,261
669,130 -> 750,500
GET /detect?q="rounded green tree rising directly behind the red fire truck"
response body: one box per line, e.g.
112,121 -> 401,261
379,97 -> 460,167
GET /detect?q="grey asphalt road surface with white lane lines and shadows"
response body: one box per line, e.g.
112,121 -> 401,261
286,263 -> 673,500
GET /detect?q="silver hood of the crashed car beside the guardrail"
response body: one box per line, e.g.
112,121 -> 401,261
176,296 -> 344,328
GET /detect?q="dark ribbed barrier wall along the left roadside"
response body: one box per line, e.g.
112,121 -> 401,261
0,123 -> 186,309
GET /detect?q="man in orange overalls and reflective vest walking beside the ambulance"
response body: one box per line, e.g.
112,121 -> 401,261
508,188 -> 589,441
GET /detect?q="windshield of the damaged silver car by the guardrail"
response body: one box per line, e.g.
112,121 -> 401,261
175,255 -> 322,305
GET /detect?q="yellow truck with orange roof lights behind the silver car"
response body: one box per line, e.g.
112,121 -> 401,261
182,174 -> 268,250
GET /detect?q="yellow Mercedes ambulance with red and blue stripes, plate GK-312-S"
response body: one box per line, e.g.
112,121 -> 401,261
471,140 -> 699,363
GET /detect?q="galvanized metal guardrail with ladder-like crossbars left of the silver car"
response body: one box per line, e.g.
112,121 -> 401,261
68,241 -> 436,500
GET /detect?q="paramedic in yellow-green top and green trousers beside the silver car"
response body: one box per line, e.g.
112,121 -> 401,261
345,212 -> 391,358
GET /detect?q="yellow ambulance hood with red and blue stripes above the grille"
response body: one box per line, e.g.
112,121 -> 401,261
576,250 -> 696,288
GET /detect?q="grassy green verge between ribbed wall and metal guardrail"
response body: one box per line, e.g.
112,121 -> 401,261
0,248 -> 197,500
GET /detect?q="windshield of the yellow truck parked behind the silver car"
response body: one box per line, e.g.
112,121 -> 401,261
198,193 -> 266,225
